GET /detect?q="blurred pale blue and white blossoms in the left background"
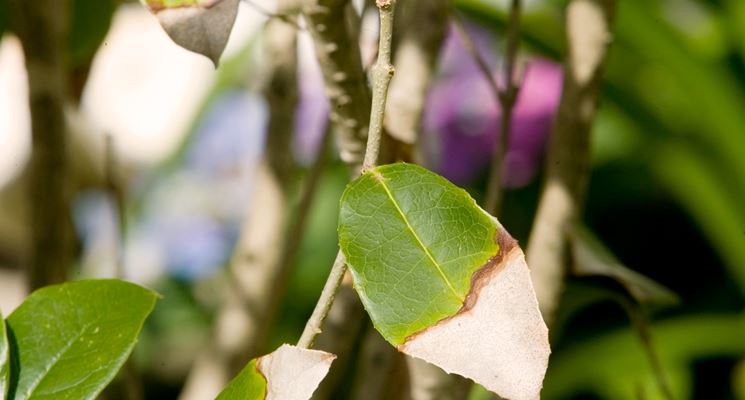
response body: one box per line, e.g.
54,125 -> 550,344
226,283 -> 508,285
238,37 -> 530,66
75,91 -> 267,283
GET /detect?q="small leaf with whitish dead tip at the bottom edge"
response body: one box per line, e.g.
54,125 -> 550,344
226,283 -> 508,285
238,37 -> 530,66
217,344 -> 336,400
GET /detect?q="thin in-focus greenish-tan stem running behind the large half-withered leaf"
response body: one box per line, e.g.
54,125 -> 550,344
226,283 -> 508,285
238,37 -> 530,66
298,0 -> 396,348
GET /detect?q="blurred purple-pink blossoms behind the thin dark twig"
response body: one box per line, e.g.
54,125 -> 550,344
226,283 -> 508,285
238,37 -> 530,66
422,24 -> 562,188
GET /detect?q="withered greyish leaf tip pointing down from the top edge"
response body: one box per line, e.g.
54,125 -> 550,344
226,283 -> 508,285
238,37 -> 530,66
141,0 -> 239,66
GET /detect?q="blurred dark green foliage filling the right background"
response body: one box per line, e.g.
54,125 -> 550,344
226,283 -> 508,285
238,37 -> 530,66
456,0 -> 745,399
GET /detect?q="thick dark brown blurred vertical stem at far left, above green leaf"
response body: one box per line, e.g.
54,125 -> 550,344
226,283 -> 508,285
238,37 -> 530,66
10,0 -> 72,290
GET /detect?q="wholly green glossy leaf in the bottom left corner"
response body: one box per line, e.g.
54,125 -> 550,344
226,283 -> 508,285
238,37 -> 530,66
7,280 -> 157,400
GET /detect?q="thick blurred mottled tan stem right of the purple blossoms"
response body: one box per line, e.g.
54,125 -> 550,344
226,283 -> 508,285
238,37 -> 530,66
525,0 -> 615,327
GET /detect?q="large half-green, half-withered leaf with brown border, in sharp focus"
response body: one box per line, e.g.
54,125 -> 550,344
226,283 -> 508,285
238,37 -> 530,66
339,164 -> 550,399
